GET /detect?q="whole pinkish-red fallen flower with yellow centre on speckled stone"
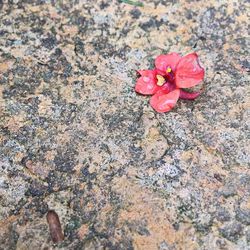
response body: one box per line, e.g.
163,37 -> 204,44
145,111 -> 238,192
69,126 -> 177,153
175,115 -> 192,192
135,53 -> 205,113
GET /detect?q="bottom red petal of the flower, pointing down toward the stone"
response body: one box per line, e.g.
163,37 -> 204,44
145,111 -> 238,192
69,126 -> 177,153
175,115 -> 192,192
150,89 -> 180,113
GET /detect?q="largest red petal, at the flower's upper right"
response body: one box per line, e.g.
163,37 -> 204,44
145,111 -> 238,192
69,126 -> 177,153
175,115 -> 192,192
175,53 -> 205,88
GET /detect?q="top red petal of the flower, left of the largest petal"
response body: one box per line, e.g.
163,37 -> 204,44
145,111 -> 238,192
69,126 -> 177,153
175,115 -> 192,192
155,53 -> 181,74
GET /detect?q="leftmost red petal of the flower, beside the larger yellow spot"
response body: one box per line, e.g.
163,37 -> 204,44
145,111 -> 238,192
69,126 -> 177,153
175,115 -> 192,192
135,76 -> 161,95
